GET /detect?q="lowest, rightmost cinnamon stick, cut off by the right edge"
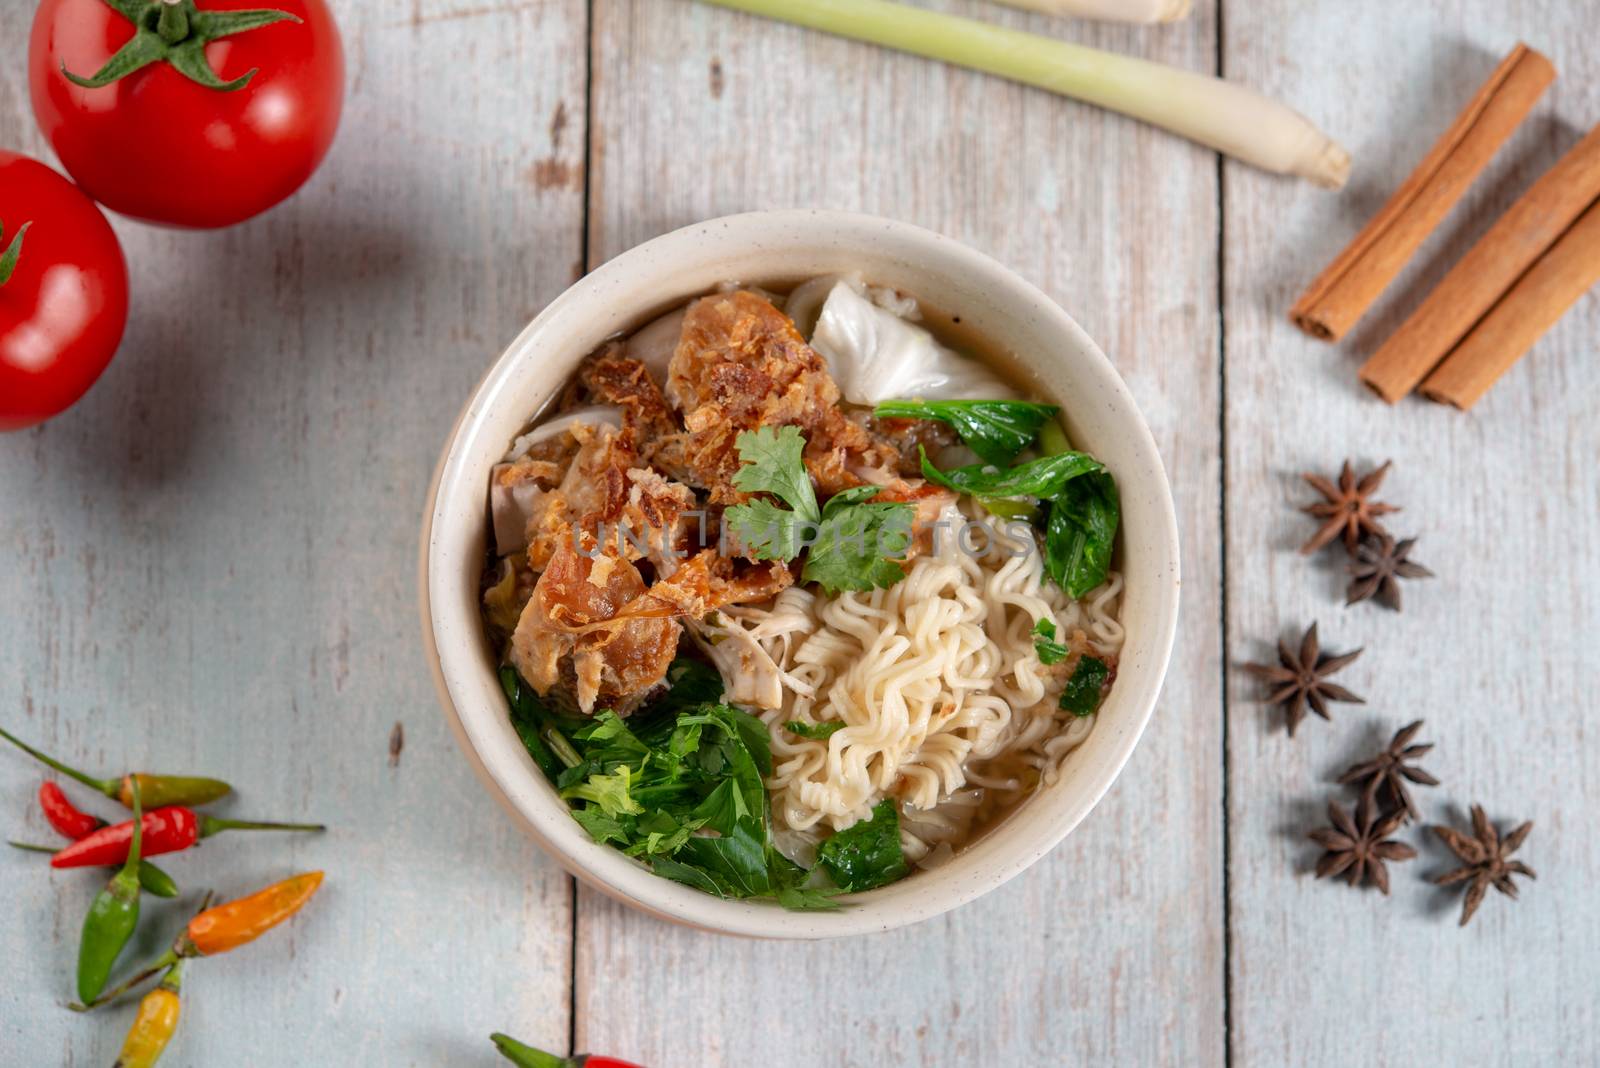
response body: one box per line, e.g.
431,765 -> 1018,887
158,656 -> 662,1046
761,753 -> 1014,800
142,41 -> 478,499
1422,191 -> 1600,409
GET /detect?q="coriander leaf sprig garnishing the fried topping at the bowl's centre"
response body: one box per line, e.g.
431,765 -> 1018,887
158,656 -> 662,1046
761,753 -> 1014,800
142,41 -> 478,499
723,427 -> 917,593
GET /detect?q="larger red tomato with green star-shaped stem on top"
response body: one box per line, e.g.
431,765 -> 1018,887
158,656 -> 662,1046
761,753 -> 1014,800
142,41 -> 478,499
29,0 -> 344,227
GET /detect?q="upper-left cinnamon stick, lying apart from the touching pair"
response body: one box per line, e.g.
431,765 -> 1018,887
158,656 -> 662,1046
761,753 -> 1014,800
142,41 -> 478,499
1290,45 -> 1555,341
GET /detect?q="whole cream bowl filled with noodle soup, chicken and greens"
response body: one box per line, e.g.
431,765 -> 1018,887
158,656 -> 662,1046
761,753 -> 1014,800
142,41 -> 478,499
421,211 -> 1179,938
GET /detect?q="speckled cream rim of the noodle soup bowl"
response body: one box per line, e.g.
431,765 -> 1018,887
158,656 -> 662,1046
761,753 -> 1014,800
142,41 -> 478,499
418,209 -> 1179,938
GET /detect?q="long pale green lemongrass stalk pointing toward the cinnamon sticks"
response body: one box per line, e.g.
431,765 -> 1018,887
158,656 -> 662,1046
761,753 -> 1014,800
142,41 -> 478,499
706,0 -> 1350,189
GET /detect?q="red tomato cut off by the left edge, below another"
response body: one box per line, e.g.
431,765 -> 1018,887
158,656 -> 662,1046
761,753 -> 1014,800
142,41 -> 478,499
0,152 -> 128,430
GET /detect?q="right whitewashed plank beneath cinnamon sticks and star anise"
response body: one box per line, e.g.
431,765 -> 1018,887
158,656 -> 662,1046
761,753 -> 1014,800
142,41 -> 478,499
1224,0 -> 1600,1065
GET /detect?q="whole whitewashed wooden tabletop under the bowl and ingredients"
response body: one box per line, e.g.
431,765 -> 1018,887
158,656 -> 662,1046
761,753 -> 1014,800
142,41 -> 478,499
0,0 -> 1600,1068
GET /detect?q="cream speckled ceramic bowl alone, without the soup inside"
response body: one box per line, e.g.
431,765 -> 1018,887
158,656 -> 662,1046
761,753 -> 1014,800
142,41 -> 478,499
421,211 -> 1178,938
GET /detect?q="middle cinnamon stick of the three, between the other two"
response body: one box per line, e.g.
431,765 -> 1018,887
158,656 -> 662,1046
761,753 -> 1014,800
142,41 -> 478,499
1360,126 -> 1600,404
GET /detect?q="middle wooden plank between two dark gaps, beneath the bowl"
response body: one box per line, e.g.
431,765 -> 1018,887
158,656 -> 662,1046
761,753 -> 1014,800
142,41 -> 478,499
576,0 -> 1222,1065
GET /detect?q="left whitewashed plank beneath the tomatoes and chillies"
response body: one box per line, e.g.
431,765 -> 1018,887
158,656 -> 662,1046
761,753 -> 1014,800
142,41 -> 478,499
0,0 -> 586,1065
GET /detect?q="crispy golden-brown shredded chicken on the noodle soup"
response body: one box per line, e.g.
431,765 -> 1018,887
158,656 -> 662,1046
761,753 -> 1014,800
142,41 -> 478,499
491,291 -> 954,715
